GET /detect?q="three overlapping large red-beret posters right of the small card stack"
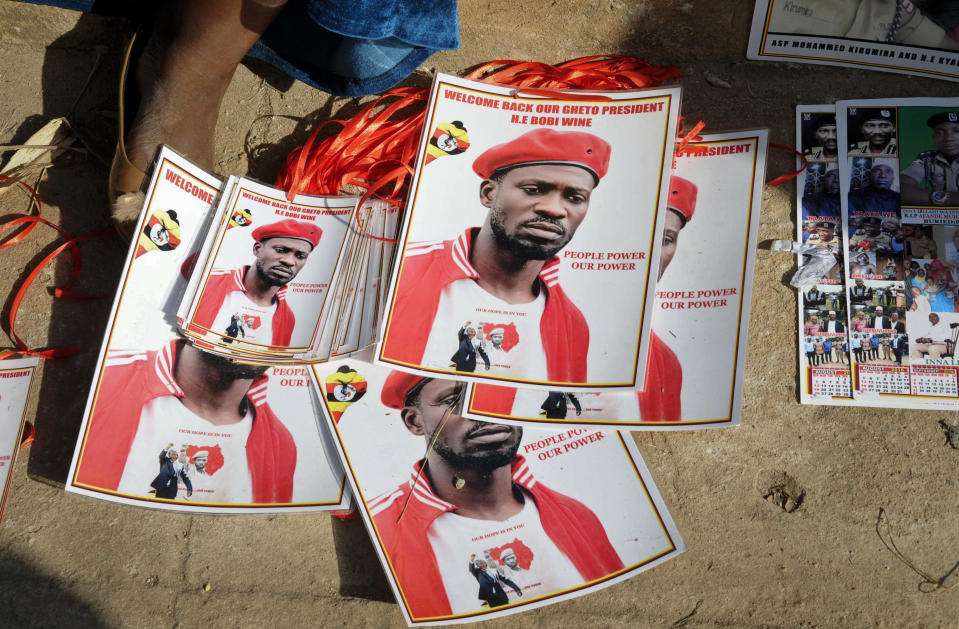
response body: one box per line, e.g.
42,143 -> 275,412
296,75 -> 767,625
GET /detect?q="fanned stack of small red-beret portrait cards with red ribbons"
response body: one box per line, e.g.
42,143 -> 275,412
177,172 -> 398,364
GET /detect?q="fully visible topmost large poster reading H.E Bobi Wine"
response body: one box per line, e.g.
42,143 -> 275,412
376,75 -> 681,390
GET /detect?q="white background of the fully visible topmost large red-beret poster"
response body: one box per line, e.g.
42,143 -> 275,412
378,74 -> 680,389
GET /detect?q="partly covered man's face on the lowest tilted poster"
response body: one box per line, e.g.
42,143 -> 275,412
402,380 -> 523,472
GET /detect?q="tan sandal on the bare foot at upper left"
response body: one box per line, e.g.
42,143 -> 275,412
108,34 -> 147,241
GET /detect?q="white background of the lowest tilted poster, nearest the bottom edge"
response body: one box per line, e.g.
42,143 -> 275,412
312,360 -> 685,626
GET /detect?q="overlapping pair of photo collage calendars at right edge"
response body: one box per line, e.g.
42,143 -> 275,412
798,99 -> 959,410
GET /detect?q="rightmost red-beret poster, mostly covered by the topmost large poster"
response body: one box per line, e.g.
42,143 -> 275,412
464,129 -> 768,430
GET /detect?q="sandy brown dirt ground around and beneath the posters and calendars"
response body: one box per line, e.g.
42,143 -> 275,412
0,0 -> 959,628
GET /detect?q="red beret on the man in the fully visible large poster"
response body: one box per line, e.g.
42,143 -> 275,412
473,129 -> 610,183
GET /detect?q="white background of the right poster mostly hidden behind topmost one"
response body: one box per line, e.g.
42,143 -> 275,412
466,129 -> 768,430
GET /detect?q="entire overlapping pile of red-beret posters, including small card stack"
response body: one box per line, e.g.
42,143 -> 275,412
50,75 -> 767,624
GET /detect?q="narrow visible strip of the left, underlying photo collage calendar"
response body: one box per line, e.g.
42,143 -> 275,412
796,105 -> 853,405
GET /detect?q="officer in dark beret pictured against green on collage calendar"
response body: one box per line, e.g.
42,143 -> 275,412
899,109 -> 959,207
